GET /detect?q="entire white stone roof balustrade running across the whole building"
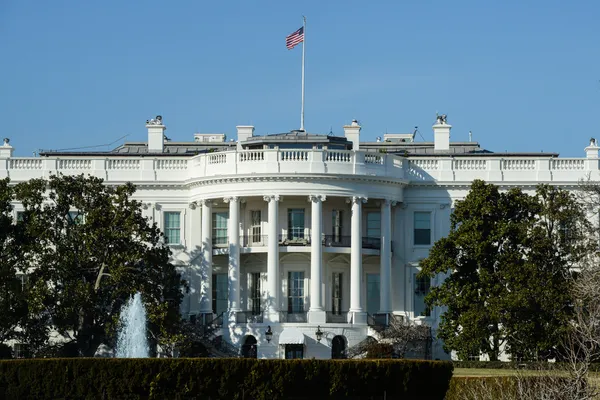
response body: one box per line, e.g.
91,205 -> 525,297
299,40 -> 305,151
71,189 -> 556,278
0,149 -> 600,182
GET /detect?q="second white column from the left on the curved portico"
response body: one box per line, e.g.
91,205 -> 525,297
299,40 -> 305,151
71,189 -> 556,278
223,196 -> 241,313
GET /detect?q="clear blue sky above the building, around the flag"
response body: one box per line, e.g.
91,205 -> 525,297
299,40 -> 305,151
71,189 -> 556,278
0,0 -> 600,157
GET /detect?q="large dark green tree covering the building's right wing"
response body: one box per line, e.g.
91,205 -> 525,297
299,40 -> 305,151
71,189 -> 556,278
421,180 -> 590,361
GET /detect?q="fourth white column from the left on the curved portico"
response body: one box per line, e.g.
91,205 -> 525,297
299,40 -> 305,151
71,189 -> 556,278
308,195 -> 326,324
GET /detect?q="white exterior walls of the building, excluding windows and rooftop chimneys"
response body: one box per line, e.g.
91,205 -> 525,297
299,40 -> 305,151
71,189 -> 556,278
5,149 -> 600,359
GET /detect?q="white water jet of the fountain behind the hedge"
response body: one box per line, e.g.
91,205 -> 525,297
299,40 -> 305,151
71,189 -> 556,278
115,293 -> 148,358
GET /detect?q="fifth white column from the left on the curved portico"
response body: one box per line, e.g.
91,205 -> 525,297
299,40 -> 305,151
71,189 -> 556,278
348,196 -> 367,324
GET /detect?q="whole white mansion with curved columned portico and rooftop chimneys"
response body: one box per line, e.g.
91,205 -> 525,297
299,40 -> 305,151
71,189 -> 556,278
0,116 -> 600,359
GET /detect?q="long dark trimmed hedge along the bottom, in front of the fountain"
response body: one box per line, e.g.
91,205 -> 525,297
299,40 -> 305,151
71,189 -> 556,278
0,358 -> 452,400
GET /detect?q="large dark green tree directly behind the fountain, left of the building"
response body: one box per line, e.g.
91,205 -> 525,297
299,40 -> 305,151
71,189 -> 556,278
15,175 -> 186,356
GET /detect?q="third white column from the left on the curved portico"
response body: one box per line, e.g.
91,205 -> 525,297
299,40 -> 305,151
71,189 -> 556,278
264,195 -> 280,322
